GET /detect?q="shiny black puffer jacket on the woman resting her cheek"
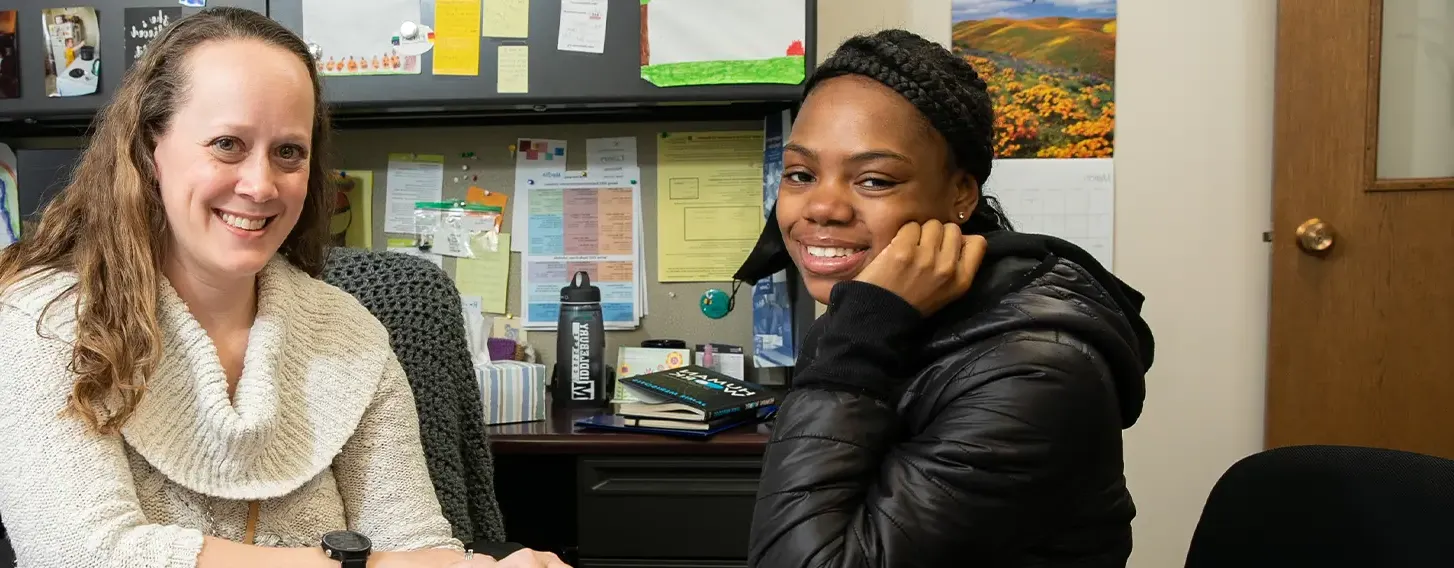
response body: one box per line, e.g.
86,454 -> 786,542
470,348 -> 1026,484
749,232 -> 1153,568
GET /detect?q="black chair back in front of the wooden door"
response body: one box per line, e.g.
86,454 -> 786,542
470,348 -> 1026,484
1186,446 -> 1454,568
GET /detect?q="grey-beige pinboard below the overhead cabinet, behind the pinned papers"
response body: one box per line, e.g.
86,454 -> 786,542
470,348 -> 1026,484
334,121 -> 779,379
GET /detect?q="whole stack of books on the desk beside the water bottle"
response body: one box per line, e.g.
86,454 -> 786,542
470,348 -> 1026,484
577,365 -> 776,436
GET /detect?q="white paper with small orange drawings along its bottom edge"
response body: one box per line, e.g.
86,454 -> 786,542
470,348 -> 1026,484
302,0 -> 423,76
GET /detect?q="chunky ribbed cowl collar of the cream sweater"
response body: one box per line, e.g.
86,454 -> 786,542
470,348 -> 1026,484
122,259 -> 385,500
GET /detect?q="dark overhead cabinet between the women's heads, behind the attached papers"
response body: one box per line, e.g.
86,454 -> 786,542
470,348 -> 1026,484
268,0 -> 817,113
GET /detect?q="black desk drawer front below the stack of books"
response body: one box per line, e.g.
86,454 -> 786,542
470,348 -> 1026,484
577,456 -> 762,559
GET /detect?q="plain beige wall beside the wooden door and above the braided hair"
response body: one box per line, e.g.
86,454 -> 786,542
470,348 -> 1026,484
819,0 -> 1277,568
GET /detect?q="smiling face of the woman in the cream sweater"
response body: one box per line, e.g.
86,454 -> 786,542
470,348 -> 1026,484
153,39 -> 314,280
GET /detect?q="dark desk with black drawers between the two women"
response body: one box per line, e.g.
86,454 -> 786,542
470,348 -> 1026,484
490,410 -> 771,568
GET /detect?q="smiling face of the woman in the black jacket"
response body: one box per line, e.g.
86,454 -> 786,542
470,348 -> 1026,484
776,76 -> 979,304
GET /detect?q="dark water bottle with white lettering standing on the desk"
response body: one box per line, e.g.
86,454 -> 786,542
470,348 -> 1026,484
553,272 -> 608,407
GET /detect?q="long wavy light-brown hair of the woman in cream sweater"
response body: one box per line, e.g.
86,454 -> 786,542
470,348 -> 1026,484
0,7 -> 333,434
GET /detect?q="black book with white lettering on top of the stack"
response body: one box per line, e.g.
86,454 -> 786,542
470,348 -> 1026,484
616,365 -> 776,421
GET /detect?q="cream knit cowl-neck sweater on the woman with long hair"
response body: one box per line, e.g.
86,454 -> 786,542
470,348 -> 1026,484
0,259 -> 461,568
